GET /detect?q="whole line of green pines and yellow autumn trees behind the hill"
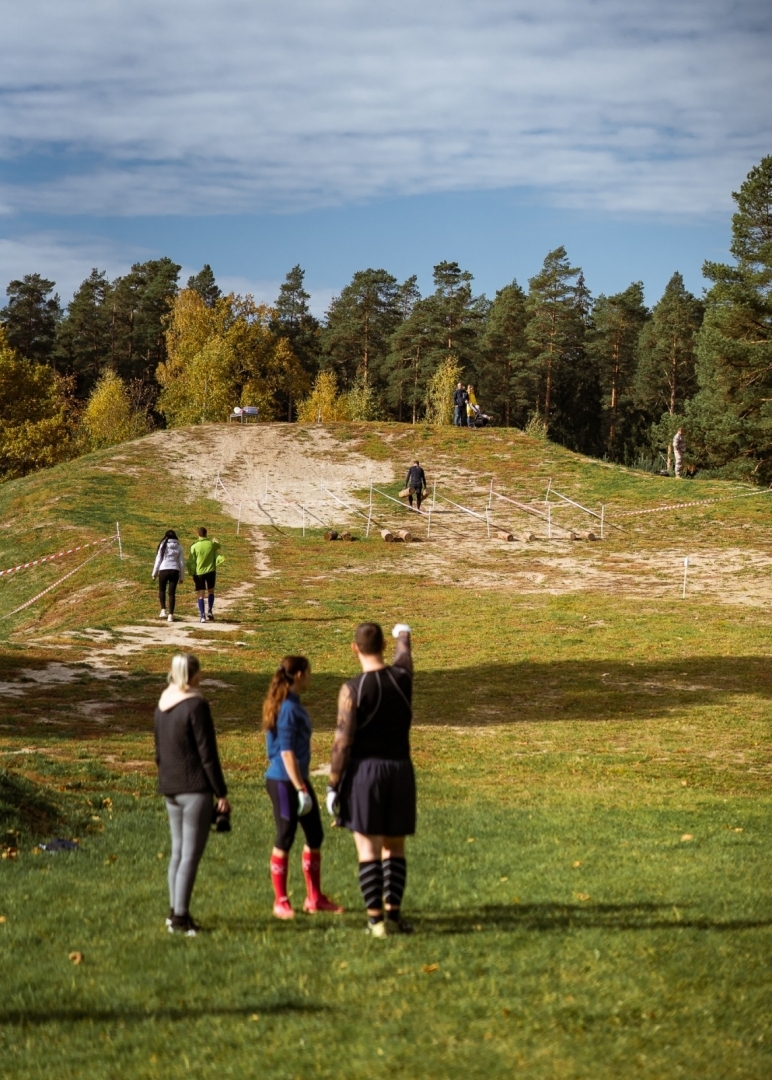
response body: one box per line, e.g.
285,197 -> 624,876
0,157 -> 772,482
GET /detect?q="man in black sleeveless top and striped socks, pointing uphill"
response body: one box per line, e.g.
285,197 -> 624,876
327,622 -> 416,937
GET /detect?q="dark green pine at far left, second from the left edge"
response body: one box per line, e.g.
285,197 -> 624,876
55,269 -> 112,397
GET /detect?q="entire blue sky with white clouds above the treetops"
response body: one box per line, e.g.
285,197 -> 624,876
0,0 -> 772,313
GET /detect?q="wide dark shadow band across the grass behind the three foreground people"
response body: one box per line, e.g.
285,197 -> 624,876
0,652 -> 772,742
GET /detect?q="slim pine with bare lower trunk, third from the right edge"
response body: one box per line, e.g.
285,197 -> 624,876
587,281 -> 649,461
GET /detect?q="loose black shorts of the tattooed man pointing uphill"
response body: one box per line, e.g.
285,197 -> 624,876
340,757 -> 416,836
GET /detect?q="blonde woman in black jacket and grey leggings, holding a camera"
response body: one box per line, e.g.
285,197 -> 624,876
154,653 -> 230,937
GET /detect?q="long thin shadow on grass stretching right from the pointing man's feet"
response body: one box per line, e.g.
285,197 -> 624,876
415,903 -> 772,934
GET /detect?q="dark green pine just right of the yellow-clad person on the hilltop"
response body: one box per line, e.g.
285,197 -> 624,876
478,281 -> 534,428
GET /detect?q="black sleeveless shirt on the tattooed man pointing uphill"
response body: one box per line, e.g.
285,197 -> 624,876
347,667 -> 412,761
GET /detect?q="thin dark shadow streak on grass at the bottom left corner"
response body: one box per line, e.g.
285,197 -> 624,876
0,1001 -> 333,1027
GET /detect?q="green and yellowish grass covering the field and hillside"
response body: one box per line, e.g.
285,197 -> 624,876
0,424 -> 772,1080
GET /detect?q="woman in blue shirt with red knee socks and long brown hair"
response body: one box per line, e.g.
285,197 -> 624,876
262,656 -> 343,919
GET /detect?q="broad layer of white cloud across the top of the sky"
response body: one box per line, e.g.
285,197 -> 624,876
0,0 -> 772,215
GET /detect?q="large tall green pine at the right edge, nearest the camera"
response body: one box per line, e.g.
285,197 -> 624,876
688,156 -> 772,483
